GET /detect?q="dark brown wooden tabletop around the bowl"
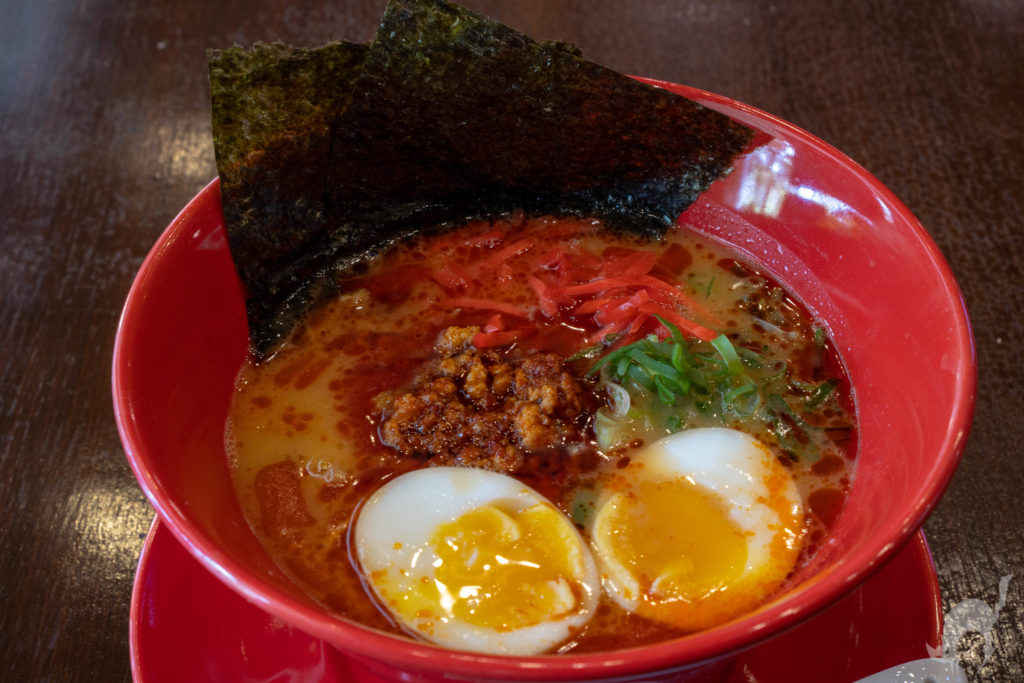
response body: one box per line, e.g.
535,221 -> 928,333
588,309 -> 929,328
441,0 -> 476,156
0,0 -> 1024,682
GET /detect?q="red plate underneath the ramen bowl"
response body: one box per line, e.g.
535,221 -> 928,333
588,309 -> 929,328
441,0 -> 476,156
130,521 -> 942,683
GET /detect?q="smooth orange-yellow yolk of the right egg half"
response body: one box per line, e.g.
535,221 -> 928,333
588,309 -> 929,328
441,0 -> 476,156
595,479 -> 746,601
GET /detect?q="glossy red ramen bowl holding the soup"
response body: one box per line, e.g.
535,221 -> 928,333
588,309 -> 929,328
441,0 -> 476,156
113,83 -> 976,681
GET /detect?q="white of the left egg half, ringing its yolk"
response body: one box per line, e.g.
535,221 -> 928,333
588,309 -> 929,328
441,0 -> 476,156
354,467 -> 600,655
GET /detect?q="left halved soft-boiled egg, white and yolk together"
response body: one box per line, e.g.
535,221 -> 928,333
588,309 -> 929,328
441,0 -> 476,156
354,467 -> 601,655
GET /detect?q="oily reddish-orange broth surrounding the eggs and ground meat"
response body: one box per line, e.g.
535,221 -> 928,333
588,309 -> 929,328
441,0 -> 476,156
225,215 -> 855,653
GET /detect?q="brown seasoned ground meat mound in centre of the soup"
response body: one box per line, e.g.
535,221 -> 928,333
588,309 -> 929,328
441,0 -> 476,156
377,327 -> 585,472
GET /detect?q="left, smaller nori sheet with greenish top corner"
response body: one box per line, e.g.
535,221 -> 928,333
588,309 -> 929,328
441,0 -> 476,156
208,42 -> 370,325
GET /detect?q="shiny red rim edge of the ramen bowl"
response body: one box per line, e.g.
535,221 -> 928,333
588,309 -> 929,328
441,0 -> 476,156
112,78 -> 977,680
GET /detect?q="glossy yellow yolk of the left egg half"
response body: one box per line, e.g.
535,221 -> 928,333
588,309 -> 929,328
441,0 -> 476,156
395,504 -> 585,631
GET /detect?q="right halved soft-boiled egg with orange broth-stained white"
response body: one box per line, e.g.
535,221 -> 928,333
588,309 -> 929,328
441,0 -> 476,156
589,428 -> 804,631
